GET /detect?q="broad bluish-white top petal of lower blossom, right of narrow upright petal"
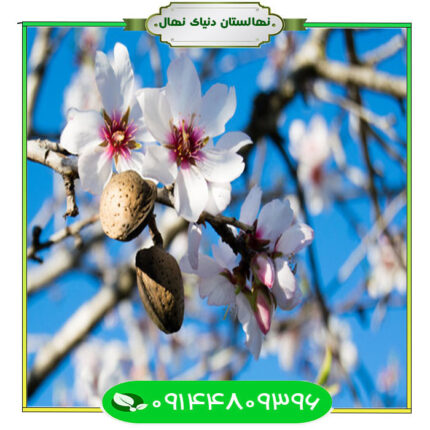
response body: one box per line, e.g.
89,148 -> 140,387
257,199 -> 294,242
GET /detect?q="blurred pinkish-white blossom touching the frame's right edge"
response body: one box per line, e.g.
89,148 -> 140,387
367,236 -> 406,298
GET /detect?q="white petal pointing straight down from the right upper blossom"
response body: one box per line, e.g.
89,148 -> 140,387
173,165 -> 208,222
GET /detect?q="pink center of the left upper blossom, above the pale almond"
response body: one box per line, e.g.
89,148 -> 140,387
100,108 -> 140,164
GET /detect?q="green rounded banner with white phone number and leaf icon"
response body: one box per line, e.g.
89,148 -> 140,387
103,381 -> 332,423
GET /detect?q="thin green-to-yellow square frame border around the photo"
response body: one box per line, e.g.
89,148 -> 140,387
18,19 -> 412,414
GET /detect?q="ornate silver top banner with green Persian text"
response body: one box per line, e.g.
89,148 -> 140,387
124,3 -> 306,48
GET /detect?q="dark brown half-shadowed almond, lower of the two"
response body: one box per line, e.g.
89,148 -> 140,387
136,245 -> 184,333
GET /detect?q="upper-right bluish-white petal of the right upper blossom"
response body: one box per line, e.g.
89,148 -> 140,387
199,84 -> 236,137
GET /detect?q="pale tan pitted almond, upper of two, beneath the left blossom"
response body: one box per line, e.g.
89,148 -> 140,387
100,170 -> 157,242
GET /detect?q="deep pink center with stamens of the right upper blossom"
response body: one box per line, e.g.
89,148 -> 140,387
166,115 -> 209,168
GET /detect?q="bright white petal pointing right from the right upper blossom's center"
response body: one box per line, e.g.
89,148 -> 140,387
196,149 -> 245,182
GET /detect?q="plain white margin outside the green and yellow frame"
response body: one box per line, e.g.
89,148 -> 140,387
0,0 -> 430,430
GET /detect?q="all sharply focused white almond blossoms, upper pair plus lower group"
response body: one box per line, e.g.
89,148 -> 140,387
61,43 -> 313,358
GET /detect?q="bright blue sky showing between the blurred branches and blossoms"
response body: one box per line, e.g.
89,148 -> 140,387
27,28 -> 406,407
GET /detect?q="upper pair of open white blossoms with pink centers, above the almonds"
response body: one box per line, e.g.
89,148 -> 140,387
61,43 -> 252,221
